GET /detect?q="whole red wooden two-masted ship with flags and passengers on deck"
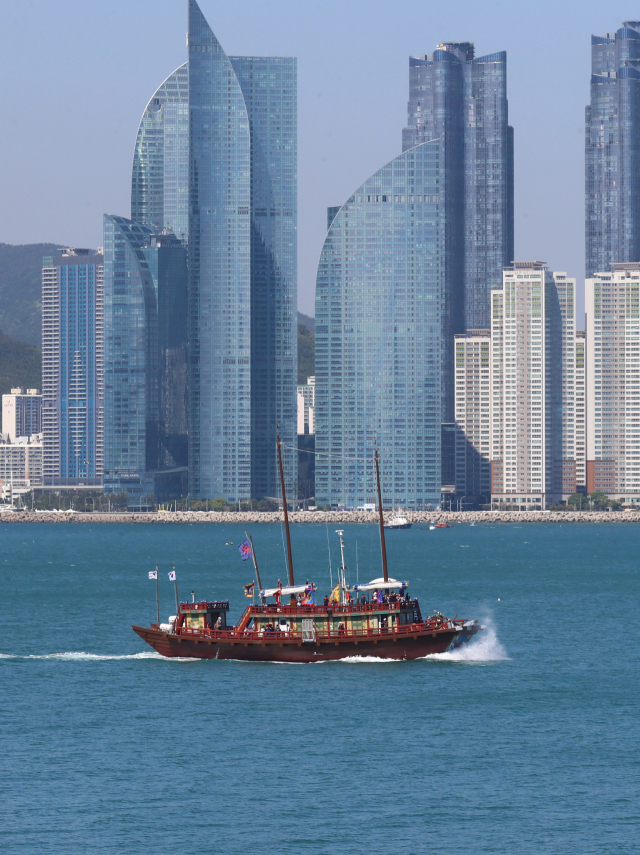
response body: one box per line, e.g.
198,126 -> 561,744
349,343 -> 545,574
133,438 -> 483,662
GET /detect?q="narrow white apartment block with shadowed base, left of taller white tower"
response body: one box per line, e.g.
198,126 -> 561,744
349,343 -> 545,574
454,330 -> 491,504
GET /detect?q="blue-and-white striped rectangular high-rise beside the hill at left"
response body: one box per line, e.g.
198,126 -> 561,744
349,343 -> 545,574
42,249 -> 104,487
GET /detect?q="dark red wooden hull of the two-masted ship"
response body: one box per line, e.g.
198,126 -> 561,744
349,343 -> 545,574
133,625 -> 480,662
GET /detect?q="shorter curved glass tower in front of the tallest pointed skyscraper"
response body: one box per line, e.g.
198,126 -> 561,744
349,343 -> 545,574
104,215 -> 187,504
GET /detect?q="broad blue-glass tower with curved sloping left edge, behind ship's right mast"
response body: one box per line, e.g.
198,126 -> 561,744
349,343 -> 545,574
316,140 -> 448,508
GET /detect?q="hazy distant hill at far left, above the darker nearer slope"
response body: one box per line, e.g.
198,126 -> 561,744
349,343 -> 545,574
0,243 -> 62,346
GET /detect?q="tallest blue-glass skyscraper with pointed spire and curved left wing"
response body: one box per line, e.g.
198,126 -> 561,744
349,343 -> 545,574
126,0 -> 297,500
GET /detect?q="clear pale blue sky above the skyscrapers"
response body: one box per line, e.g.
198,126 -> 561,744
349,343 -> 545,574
0,0 -> 639,314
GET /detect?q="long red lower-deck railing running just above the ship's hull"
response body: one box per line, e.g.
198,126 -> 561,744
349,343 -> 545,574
172,620 -> 462,643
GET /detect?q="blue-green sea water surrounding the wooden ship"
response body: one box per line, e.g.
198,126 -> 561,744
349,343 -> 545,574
0,524 -> 640,855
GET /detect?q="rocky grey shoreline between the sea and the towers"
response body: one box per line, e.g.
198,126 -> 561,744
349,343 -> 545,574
0,509 -> 640,527
